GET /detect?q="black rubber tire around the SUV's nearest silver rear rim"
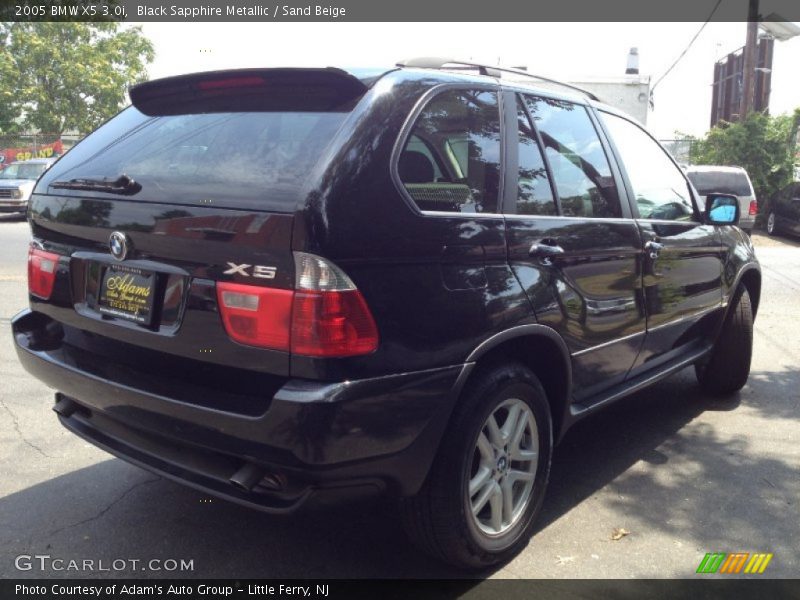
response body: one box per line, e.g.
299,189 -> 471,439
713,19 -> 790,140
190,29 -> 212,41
401,363 -> 553,569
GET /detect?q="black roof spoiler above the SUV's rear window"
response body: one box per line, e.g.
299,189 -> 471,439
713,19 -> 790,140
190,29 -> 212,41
129,67 -> 367,117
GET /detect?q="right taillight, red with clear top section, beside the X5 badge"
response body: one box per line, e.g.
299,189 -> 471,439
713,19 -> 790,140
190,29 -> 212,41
217,252 -> 378,358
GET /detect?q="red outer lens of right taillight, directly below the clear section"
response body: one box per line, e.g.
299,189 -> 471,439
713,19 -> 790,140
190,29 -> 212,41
292,290 -> 378,357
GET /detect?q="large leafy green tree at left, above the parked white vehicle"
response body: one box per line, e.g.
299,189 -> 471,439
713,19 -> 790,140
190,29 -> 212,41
0,22 -> 155,133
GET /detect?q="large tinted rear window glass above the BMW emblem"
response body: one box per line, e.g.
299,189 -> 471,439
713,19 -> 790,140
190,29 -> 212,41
39,108 -> 347,212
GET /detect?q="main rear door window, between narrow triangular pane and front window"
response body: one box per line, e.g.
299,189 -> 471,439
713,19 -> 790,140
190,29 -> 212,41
525,96 -> 622,218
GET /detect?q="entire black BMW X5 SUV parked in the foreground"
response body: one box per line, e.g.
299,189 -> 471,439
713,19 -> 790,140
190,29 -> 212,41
13,60 -> 761,568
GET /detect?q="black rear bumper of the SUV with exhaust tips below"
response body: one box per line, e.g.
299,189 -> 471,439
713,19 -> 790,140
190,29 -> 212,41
12,310 -> 471,512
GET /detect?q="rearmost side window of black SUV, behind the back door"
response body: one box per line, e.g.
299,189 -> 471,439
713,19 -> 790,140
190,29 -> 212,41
397,90 -> 500,213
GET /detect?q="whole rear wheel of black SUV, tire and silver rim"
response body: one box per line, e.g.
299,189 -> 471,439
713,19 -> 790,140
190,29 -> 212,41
402,363 -> 553,568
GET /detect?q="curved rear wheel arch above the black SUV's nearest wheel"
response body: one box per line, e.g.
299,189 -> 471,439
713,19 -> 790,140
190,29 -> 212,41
460,325 -> 572,441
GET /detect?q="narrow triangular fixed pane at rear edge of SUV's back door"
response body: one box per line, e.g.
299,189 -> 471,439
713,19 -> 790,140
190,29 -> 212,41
517,100 -> 556,215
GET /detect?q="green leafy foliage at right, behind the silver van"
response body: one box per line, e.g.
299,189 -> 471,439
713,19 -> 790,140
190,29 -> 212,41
690,108 -> 800,206
